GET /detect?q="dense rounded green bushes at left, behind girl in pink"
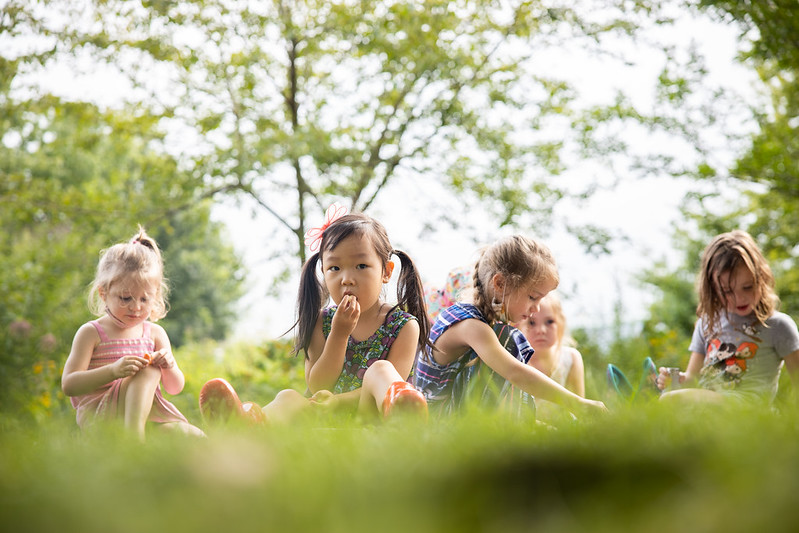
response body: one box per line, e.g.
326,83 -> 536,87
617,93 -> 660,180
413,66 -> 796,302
0,21 -> 242,416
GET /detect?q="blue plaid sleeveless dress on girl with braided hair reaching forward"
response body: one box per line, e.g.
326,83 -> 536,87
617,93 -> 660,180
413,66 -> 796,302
413,303 -> 535,416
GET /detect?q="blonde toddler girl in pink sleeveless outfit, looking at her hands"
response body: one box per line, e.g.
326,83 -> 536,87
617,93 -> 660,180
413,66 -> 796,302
61,227 -> 203,440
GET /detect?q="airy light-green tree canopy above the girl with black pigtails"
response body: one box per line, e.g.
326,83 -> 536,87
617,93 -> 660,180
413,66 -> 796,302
20,0 -> 724,268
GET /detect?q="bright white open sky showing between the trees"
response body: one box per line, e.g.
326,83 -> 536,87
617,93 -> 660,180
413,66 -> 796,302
216,10 -> 757,338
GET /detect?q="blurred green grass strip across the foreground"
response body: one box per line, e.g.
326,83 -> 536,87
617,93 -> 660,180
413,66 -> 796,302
0,402 -> 799,533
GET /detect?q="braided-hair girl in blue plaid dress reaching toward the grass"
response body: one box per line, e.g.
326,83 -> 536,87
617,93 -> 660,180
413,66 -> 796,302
414,235 -> 605,415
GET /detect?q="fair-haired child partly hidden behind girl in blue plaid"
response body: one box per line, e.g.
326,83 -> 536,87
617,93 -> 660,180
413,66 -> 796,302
515,291 -> 585,422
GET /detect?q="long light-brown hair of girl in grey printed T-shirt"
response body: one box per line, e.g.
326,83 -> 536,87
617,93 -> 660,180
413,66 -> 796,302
696,230 -> 780,334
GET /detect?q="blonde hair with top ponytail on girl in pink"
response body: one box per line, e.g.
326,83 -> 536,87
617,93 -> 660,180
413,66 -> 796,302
88,226 -> 169,321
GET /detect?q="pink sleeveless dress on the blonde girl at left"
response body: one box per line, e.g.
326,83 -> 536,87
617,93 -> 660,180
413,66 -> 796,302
71,320 -> 188,428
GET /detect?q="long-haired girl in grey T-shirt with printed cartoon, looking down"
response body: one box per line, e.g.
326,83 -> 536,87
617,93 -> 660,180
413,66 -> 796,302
657,230 -> 799,405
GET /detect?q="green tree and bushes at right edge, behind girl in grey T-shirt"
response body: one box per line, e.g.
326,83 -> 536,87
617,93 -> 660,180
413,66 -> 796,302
643,0 -> 799,370
